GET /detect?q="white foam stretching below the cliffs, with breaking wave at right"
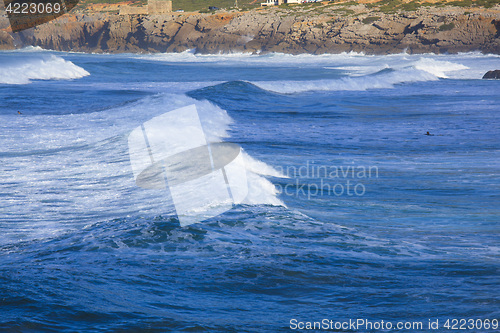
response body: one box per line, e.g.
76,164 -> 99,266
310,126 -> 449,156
128,50 -> 500,94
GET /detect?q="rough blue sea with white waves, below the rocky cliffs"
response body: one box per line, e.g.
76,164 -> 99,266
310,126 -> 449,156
0,48 -> 500,332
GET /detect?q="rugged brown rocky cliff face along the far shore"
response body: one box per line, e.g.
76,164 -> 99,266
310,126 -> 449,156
0,5 -> 500,54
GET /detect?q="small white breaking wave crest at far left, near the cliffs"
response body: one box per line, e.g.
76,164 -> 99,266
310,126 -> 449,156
0,53 -> 90,84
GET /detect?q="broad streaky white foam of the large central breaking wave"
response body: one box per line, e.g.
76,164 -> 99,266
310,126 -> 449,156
0,94 -> 282,242
